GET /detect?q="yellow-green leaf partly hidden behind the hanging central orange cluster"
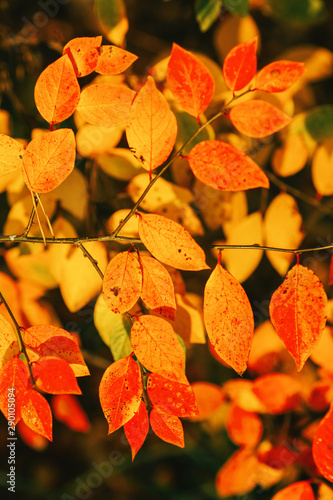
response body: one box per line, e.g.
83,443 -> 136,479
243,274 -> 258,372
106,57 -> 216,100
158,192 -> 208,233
94,294 -> 133,361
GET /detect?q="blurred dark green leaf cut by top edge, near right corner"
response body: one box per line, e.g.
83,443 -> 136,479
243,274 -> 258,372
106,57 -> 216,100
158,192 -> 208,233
268,0 -> 326,24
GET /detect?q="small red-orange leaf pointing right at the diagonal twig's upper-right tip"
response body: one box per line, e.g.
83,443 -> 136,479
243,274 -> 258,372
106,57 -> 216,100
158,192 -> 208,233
256,61 -> 305,92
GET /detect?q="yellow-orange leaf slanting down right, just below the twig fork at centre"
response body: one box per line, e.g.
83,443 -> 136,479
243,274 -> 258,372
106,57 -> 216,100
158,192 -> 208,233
139,214 -> 208,271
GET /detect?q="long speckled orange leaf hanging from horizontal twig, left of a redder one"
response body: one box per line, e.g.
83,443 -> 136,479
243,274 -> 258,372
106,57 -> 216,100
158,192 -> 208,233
204,263 -> 254,374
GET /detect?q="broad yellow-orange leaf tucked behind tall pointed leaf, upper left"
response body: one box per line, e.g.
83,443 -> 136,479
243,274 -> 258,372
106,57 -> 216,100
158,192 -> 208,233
77,83 -> 135,127
